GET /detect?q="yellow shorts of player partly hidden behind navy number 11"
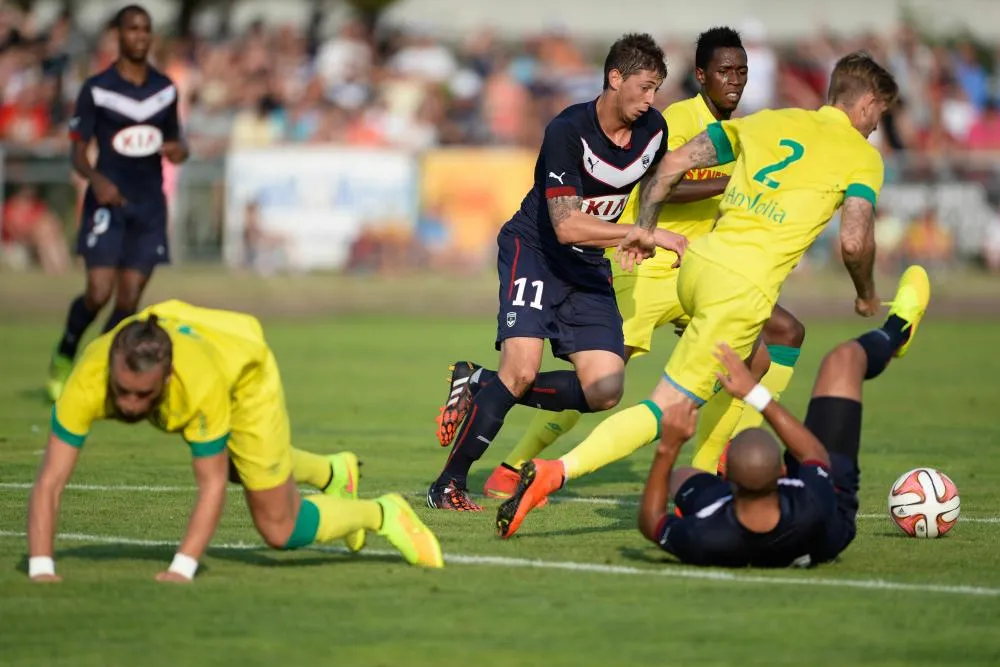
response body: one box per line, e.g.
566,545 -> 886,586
614,271 -> 689,357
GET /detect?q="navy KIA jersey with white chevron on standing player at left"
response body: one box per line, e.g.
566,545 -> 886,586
70,65 -> 180,201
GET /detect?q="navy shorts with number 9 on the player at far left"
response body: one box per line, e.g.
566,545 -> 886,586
76,190 -> 170,275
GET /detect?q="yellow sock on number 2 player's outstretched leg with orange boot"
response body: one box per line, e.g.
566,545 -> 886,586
559,401 -> 663,480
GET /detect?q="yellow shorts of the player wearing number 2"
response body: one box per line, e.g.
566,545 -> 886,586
664,251 -> 774,404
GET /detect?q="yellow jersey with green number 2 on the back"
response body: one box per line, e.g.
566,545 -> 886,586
687,106 -> 883,302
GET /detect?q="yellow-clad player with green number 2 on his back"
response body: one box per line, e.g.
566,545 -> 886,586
497,53 -> 898,537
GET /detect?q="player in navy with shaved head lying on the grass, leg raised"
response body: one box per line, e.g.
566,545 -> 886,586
639,266 -> 930,567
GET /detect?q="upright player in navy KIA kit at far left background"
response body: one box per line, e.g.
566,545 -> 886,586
46,5 -> 188,401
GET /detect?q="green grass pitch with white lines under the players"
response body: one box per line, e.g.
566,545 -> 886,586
0,308 -> 1000,667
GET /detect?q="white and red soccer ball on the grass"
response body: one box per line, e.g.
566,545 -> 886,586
889,468 -> 961,537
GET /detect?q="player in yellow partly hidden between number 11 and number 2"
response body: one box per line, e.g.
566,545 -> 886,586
483,27 -> 805,498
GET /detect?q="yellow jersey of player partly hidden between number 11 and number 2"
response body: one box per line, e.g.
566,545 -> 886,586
611,95 -> 735,276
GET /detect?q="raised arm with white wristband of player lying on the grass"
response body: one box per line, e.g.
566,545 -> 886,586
715,343 -> 830,466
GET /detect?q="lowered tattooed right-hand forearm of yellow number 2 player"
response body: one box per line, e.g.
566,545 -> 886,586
840,197 -> 879,317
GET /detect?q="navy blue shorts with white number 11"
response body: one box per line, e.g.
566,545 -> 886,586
496,230 -> 625,359
